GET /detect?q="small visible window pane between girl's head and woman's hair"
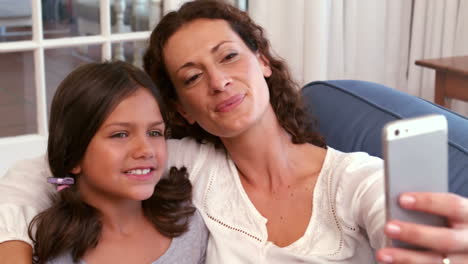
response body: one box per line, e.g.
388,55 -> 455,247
112,40 -> 147,69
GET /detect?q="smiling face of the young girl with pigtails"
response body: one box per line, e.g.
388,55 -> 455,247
72,88 -> 166,203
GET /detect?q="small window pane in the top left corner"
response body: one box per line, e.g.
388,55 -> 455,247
0,0 -> 32,42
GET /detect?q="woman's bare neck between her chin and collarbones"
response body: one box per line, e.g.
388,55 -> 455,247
223,109 -> 326,192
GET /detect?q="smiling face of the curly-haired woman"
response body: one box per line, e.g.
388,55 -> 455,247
163,19 -> 272,138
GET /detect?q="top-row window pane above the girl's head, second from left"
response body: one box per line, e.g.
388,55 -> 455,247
42,0 -> 101,39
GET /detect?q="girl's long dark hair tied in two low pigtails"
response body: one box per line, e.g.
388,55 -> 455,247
28,62 -> 195,263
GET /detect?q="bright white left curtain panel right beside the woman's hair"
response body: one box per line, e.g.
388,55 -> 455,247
248,0 -> 329,85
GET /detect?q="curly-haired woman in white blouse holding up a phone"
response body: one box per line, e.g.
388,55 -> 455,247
0,1 -> 468,263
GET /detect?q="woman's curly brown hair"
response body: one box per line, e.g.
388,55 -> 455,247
144,0 -> 326,148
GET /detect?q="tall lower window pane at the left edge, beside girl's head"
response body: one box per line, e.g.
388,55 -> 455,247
0,51 -> 37,137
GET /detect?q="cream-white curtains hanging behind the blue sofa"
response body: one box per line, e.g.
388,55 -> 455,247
249,0 -> 468,116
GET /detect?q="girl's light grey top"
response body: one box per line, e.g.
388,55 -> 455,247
47,211 -> 208,264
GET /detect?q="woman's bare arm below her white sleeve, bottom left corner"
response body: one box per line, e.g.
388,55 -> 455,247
0,240 -> 32,264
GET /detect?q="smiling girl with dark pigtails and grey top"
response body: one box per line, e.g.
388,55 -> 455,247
29,62 -> 207,263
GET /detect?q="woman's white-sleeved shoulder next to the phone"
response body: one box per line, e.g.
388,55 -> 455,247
323,148 -> 385,241
